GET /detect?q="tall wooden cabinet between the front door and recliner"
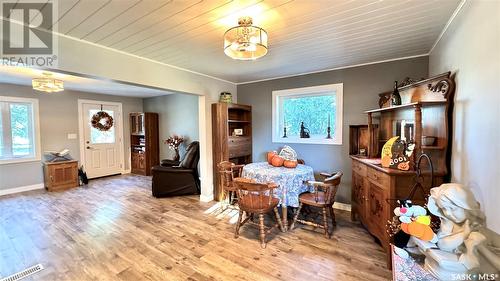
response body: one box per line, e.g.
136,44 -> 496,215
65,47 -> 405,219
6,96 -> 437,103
130,112 -> 160,176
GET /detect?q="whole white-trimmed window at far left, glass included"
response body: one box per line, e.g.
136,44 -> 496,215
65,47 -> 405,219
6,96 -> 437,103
0,96 -> 40,164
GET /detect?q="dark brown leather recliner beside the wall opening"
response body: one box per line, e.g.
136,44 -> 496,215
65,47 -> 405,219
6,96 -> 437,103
151,141 -> 200,197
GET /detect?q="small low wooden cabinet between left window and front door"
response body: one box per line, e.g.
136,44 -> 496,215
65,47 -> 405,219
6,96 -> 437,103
43,160 -> 78,191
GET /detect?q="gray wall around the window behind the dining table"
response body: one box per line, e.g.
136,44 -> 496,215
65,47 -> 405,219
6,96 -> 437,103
238,57 -> 428,203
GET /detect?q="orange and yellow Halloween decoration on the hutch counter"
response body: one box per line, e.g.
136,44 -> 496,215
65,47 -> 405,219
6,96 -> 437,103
381,136 -> 415,168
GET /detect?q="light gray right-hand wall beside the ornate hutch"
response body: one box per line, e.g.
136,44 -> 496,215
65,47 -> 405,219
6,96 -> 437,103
429,1 -> 500,233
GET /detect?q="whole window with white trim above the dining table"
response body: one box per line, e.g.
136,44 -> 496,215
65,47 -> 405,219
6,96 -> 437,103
272,83 -> 343,144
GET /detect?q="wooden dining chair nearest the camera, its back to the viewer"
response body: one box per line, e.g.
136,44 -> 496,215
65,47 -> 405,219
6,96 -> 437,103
234,178 -> 283,248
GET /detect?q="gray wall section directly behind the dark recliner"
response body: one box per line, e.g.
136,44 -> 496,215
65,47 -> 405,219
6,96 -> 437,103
144,94 -> 199,159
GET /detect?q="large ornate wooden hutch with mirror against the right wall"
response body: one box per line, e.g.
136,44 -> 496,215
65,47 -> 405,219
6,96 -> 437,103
350,72 -> 454,262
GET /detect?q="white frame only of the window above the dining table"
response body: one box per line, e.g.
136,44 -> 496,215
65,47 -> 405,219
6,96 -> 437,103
272,83 -> 344,145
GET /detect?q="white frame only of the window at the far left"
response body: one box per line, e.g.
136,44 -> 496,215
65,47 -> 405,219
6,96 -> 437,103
0,96 -> 41,165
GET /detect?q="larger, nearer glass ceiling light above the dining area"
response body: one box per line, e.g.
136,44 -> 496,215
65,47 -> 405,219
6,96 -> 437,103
224,17 -> 267,60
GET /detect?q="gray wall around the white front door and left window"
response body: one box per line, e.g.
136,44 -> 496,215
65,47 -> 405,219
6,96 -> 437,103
0,84 -> 142,189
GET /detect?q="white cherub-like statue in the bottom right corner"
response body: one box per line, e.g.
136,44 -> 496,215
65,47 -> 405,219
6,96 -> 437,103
415,183 -> 486,280
